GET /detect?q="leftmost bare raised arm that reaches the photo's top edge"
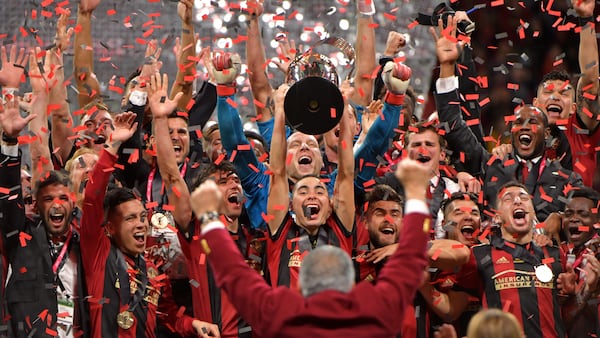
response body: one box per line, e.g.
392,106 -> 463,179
73,0 -> 101,107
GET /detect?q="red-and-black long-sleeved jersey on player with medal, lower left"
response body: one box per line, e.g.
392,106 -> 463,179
80,149 -> 195,338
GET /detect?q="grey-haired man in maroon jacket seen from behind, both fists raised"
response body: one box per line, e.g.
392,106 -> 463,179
192,159 -> 431,337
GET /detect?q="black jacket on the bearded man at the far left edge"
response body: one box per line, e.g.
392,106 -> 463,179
0,154 -> 89,337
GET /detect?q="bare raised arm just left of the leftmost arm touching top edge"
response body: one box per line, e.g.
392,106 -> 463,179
46,9 -> 75,167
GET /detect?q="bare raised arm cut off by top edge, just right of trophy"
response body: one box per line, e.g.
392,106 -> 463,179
350,0 -> 377,107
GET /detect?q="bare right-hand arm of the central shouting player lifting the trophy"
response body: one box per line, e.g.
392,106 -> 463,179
332,81 -> 356,232
